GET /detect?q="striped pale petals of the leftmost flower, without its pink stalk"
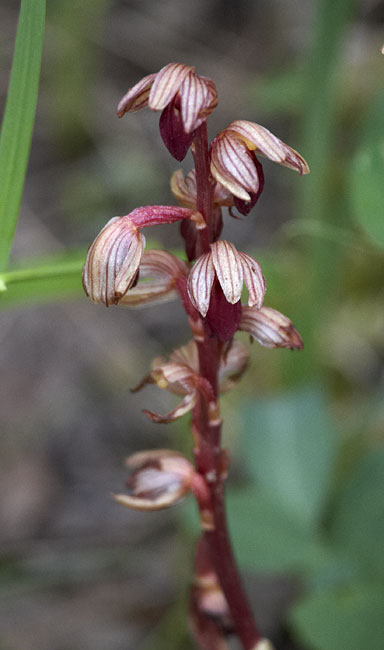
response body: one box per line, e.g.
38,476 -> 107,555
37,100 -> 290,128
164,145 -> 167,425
83,215 -> 145,306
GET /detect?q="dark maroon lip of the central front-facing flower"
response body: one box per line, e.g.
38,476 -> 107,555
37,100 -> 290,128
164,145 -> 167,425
204,280 -> 242,341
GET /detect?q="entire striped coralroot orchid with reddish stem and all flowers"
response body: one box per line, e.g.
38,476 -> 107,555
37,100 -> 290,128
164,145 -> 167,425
83,63 -> 309,650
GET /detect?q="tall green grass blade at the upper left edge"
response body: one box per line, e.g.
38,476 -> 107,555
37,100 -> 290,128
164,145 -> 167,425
0,0 -> 45,271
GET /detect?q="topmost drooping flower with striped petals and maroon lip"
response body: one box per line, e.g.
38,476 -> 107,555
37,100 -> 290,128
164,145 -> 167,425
117,63 -> 217,160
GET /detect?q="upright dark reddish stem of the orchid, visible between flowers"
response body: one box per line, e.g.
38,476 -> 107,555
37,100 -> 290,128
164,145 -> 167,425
192,123 -> 260,650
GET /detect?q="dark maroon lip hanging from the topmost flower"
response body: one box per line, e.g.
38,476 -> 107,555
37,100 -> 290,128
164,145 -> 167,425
159,98 -> 194,161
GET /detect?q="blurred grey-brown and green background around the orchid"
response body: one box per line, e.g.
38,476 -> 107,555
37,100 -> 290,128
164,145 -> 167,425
0,0 -> 384,650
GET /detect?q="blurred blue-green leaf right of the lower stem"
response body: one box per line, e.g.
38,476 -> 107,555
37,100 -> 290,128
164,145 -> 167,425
242,389 -> 338,528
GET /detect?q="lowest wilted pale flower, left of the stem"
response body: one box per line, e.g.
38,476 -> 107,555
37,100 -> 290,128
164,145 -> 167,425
114,449 -> 195,510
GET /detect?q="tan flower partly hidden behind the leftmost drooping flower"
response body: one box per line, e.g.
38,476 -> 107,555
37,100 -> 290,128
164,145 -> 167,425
119,249 -> 188,307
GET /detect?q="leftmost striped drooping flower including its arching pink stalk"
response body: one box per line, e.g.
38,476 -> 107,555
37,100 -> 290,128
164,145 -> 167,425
83,205 -> 205,307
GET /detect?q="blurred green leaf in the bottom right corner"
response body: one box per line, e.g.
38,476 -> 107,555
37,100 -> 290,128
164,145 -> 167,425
290,584 -> 384,650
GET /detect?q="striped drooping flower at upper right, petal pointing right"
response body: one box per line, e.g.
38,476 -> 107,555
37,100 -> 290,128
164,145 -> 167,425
211,120 -> 309,214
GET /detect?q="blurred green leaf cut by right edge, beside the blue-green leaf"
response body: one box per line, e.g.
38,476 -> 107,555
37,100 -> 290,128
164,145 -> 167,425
330,449 -> 384,579
